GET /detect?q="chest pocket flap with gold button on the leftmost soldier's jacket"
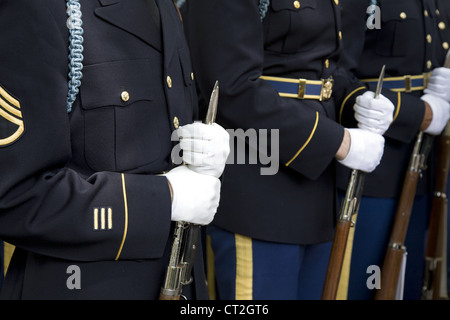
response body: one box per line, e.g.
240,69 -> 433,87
80,60 -> 156,110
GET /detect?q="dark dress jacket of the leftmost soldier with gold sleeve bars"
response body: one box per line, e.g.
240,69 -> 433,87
0,0 -> 206,299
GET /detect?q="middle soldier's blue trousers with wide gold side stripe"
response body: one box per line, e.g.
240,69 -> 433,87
207,225 -> 331,300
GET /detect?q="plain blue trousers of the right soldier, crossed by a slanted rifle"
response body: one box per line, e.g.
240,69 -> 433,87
348,196 -> 430,300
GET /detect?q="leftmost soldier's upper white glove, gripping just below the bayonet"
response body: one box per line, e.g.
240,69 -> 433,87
178,122 -> 230,178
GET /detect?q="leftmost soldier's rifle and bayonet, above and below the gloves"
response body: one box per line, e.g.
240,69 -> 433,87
159,81 -> 219,300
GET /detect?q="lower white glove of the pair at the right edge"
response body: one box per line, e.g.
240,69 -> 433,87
420,93 -> 450,135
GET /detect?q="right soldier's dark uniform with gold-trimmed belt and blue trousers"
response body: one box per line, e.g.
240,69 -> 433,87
337,0 -> 443,299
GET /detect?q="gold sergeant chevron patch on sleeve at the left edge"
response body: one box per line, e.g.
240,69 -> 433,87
0,86 -> 25,147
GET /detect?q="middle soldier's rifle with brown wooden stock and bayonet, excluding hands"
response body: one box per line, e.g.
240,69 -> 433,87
322,66 -> 385,300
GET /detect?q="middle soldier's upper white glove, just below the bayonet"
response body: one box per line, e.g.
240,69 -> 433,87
353,91 -> 394,135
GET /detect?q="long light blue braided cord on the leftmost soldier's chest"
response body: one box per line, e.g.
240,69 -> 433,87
66,0 -> 83,113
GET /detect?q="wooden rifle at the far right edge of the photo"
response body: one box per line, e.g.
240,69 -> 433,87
422,122 -> 450,300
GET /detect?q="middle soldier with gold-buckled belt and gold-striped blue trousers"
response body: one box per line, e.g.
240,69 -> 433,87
183,0 -> 393,299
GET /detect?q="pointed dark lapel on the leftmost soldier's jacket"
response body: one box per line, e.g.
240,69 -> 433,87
95,0 -> 162,51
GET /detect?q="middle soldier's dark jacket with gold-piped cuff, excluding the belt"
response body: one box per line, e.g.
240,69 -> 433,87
184,0 -> 344,244
